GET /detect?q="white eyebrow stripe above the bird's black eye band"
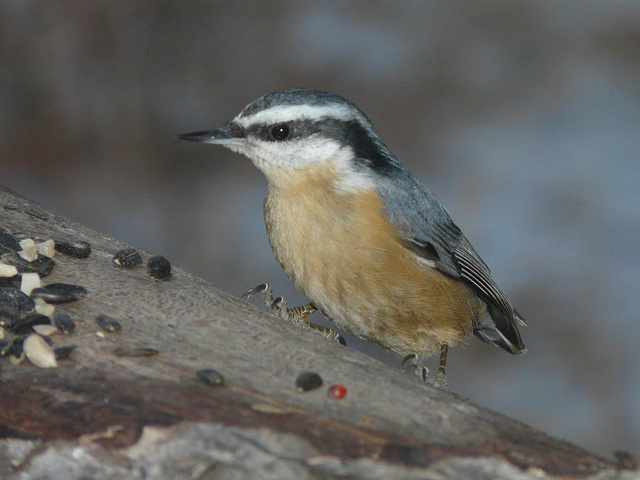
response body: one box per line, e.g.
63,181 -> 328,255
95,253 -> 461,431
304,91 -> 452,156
234,104 -> 367,128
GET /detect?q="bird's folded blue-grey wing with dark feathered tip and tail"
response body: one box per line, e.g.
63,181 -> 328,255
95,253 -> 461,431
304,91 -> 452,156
379,172 -> 525,354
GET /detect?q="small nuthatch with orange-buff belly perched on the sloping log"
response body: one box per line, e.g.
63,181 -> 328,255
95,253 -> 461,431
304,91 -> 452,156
178,88 -> 526,388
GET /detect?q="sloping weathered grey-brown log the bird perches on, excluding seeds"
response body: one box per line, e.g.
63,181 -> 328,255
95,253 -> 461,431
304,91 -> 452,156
0,188 -> 638,480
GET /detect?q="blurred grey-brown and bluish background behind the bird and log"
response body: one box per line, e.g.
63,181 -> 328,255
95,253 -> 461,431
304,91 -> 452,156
0,0 -> 640,456
